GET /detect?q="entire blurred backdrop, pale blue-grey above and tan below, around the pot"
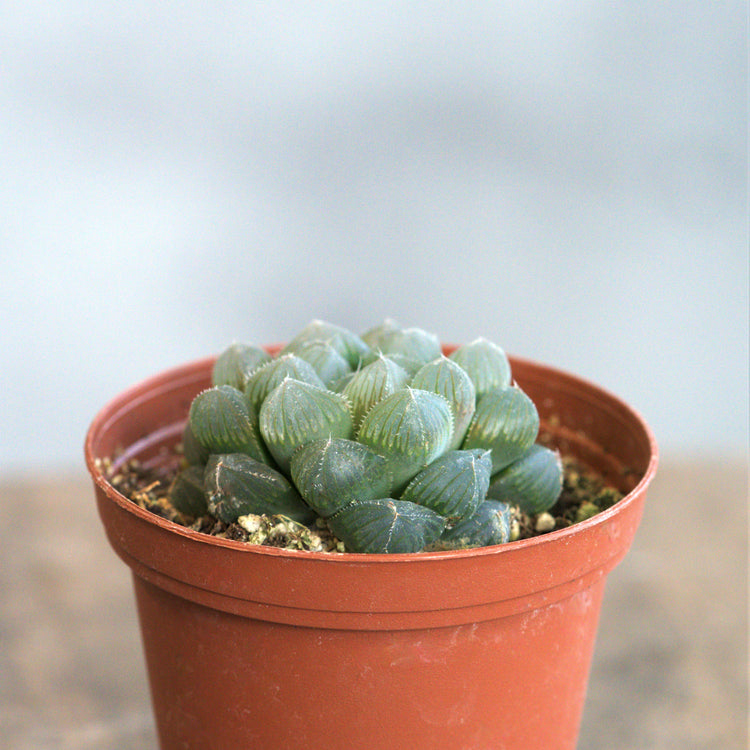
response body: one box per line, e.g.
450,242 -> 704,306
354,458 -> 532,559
0,5 -> 748,750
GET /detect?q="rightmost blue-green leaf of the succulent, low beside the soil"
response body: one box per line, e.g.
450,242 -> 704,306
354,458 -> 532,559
487,444 -> 563,515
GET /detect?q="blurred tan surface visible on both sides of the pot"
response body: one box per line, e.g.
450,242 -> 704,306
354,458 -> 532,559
0,460 -> 748,750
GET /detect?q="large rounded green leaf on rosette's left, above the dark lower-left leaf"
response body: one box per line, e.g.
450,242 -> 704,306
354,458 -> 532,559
189,385 -> 271,462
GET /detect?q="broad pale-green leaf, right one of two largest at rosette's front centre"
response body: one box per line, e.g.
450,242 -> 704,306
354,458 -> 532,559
357,388 -> 453,492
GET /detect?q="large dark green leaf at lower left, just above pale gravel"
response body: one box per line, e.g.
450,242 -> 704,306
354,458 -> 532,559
204,453 -> 315,523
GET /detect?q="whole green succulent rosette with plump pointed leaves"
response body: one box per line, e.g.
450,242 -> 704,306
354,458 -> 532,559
170,320 -> 562,553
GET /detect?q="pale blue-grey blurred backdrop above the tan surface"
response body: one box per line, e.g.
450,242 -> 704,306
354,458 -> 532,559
0,0 -> 748,473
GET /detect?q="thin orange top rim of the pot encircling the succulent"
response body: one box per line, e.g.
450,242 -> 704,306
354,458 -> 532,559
84,352 -> 659,565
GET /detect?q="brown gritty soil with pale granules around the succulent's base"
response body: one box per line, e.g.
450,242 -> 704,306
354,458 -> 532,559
100,440 -> 623,553
